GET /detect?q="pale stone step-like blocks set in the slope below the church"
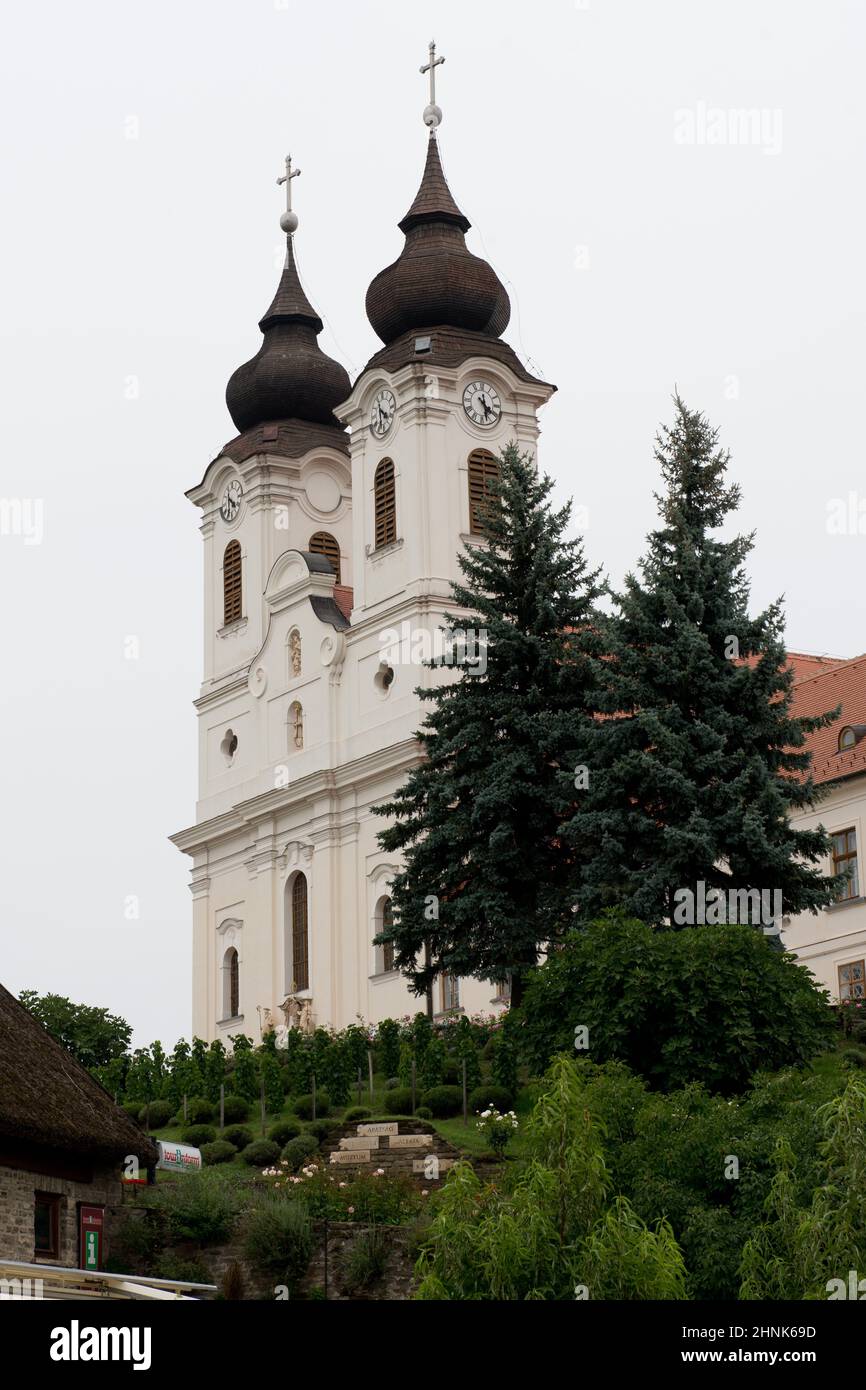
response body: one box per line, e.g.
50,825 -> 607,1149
327,1116 -> 460,1183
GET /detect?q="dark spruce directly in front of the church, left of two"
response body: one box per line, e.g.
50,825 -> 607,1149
377,445 -> 599,1004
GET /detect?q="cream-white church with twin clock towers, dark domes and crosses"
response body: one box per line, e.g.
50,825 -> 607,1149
172,44 -> 555,1041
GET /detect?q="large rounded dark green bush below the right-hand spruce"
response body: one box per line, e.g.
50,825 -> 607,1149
506,915 -> 833,1094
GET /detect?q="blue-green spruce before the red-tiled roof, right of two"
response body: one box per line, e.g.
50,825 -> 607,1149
564,396 -> 837,924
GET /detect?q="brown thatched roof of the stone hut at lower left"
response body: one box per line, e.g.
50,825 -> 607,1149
0,984 -> 157,1163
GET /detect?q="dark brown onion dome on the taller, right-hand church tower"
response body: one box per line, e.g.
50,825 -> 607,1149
367,133 -> 512,343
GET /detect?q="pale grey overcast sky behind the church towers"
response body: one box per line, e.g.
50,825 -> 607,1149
0,0 -> 866,1045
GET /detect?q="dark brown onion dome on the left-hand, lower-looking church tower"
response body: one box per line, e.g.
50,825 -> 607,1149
225,236 -> 352,434
